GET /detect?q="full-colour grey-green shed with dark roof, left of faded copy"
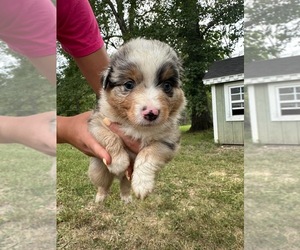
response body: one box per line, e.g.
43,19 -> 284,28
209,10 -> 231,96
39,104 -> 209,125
203,56 -> 244,144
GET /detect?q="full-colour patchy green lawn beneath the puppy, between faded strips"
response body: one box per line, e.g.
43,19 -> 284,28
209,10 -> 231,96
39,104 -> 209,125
57,128 -> 244,250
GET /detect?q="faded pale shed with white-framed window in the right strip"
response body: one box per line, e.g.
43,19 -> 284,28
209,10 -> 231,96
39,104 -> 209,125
245,56 -> 300,145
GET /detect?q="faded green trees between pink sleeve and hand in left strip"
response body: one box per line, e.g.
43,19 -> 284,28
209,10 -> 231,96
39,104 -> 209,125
0,44 -> 56,116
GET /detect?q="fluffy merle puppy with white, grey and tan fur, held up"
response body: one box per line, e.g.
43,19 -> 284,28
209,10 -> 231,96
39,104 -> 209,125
89,38 -> 186,203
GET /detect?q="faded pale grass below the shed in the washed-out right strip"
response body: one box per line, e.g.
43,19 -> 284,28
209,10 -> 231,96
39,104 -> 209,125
245,144 -> 300,249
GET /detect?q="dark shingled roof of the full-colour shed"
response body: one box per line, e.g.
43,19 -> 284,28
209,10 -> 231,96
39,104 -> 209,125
203,56 -> 244,80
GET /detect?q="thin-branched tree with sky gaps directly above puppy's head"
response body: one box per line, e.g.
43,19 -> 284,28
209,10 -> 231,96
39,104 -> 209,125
90,0 -> 159,47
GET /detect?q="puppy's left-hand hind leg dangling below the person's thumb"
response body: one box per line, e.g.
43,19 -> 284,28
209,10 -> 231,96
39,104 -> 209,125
88,157 -> 114,203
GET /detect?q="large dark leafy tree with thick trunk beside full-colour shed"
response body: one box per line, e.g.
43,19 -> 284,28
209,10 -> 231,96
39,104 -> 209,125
166,0 -> 243,131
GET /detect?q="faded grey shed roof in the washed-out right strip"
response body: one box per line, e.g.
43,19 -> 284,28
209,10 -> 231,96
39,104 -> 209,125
245,56 -> 300,78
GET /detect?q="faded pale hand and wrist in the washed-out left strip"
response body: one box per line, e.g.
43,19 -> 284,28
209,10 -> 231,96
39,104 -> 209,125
0,111 -> 56,156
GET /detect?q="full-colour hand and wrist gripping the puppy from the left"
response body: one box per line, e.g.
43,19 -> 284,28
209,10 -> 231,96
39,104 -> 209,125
57,111 -> 111,165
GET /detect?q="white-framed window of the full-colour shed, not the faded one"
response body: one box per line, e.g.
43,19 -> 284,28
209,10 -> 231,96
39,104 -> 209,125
224,83 -> 244,121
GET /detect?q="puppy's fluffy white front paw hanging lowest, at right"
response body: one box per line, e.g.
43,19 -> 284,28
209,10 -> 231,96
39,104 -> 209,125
131,171 -> 155,200
